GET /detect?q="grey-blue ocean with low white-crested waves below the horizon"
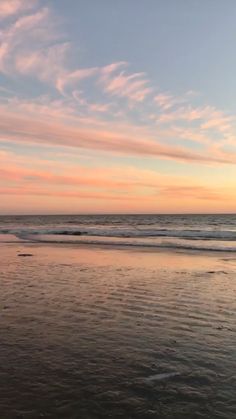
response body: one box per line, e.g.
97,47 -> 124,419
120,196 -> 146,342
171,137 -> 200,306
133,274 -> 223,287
0,214 -> 236,252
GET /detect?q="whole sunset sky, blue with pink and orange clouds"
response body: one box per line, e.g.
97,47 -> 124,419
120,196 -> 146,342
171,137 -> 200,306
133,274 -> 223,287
0,0 -> 236,214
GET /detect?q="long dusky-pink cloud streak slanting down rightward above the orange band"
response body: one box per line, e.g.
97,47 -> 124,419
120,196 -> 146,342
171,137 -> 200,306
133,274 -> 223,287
0,108 -> 236,163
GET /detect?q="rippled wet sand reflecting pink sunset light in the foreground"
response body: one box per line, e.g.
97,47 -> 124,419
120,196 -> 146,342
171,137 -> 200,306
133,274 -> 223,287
0,243 -> 236,419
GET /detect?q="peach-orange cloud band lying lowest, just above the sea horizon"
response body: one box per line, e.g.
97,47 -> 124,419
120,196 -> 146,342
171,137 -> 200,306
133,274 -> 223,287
0,153 -> 230,205
